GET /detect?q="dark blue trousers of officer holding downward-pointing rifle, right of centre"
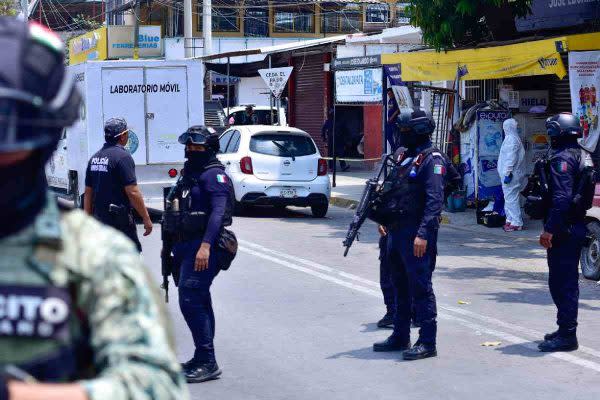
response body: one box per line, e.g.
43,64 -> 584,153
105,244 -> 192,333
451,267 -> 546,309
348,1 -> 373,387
388,227 -> 437,345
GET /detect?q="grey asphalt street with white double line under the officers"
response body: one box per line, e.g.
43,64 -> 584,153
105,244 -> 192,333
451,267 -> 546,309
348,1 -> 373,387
142,208 -> 600,400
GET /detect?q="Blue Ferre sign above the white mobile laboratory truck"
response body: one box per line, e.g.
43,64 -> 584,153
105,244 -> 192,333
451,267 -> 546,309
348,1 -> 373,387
108,26 -> 163,59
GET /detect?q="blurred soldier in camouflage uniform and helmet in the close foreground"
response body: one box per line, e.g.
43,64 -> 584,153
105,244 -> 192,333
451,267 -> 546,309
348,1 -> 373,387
0,17 -> 188,400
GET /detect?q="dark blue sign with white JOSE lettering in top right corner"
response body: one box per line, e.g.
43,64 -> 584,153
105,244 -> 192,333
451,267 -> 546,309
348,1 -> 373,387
515,0 -> 600,32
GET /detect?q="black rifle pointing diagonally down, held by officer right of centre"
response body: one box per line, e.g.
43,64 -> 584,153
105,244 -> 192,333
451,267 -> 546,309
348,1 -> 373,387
343,154 -> 396,257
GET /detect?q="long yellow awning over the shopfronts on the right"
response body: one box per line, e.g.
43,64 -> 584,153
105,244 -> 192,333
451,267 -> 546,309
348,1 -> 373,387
381,38 -> 567,82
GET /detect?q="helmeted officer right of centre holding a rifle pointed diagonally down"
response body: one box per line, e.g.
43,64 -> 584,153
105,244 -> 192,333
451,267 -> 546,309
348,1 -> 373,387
373,110 -> 447,360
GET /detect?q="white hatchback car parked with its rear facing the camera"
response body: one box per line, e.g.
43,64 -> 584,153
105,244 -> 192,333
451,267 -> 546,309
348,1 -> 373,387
218,125 -> 331,218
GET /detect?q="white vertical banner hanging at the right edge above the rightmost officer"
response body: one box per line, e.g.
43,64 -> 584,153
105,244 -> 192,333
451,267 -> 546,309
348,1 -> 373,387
569,51 -> 600,152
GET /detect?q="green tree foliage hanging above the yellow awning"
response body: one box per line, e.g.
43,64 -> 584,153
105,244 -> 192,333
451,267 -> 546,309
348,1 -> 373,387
407,0 -> 532,50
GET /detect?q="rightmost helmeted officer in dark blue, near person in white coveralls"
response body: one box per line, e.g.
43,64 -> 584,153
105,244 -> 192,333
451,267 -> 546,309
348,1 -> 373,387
539,113 -> 593,352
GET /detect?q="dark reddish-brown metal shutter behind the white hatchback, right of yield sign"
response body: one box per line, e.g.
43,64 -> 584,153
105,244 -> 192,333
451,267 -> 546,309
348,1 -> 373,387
293,54 -> 327,154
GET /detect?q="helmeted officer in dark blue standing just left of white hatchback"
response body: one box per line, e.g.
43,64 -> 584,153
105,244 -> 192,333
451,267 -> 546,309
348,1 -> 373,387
173,126 -> 233,383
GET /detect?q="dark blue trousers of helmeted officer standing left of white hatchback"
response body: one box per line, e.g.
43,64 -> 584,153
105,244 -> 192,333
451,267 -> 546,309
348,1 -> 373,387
173,240 -> 220,364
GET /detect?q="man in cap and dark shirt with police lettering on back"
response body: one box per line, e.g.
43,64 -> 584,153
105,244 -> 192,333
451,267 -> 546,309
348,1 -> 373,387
83,118 -> 152,251
